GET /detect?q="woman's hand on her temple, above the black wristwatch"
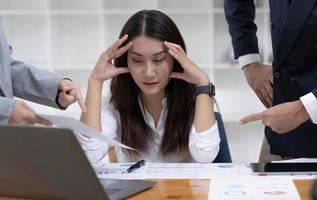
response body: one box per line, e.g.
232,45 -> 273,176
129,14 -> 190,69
164,41 -> 209,86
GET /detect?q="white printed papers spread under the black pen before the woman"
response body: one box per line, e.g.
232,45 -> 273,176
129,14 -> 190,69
94,162 -> 252,179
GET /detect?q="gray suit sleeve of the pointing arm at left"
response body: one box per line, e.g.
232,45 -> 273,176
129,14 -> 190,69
11,59 -> 62,108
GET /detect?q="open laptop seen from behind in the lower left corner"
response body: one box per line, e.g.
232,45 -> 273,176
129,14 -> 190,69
0,126 -> 153,200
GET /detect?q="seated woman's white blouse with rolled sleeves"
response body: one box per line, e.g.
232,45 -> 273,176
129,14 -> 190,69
79,98 -> 220,164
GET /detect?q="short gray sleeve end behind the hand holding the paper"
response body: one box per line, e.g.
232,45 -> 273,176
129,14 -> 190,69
0,96 -> 15,124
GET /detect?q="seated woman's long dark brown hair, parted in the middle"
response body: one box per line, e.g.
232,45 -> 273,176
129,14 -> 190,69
110,10 -> 195,155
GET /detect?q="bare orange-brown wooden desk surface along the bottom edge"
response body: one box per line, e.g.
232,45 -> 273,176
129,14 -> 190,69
0,180 -> 313,200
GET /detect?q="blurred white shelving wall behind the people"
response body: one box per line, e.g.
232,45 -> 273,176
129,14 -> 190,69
0,0 -> 272,162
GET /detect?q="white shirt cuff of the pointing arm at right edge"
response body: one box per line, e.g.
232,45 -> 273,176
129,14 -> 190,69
300,93 -> 317,124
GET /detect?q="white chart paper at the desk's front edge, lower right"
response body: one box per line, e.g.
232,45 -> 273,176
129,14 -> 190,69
208,175 -> 300,200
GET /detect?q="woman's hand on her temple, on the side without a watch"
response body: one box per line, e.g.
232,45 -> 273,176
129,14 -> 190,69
90,35 -> 132,82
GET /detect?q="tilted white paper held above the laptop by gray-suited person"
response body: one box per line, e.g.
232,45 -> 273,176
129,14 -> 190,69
40,115 -> 135,150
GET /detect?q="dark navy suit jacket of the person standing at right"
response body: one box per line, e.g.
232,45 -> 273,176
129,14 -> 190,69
225,0 -> 317,157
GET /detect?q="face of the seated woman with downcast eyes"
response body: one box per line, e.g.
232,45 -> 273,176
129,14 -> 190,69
128,36 -> 173,96
